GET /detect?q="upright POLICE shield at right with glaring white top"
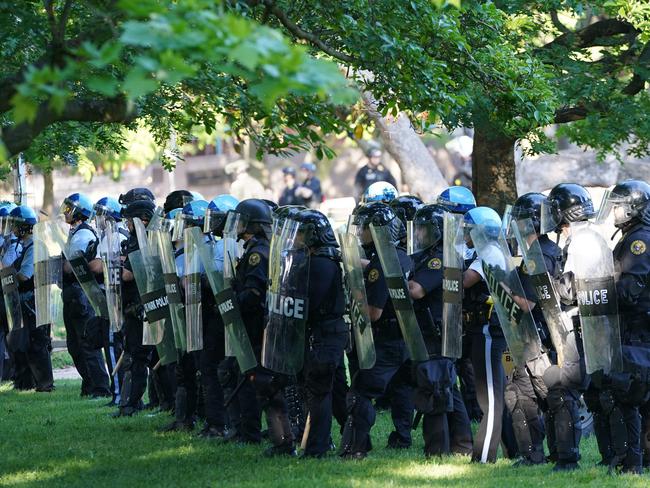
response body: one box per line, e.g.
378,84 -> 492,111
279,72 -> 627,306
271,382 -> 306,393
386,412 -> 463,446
565,222 -> 623,374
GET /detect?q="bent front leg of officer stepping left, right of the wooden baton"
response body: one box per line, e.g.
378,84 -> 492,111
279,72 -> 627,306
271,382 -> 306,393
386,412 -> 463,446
341,342 -> 394,459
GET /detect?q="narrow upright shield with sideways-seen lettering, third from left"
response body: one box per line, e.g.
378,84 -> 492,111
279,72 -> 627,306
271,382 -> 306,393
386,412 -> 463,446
99,220 -> 122,332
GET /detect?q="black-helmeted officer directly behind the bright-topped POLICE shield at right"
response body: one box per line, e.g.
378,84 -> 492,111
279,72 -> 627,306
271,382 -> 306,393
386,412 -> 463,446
540,183 -> 592,471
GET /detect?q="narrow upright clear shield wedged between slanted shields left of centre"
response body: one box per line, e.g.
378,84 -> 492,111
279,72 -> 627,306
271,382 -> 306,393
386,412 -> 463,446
183,227 -> 204,351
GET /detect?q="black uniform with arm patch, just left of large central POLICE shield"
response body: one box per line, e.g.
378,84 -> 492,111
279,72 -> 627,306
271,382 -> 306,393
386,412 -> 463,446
219,236 -> 269,444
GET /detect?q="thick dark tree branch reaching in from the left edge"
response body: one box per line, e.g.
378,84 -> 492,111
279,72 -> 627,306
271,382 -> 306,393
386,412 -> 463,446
2,97 -> 137,156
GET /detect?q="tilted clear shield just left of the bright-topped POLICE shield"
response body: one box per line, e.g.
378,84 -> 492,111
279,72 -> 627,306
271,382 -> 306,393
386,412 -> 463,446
510,218 -> 578,367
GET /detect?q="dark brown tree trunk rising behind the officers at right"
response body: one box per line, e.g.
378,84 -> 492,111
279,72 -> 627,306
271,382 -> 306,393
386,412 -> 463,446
472,124 -> 517,214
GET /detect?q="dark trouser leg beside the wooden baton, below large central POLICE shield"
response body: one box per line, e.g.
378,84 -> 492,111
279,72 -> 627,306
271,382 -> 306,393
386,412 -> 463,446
305,333 -> 347,457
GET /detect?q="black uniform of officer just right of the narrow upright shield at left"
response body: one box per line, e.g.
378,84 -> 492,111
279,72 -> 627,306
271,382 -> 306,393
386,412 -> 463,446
120,234 -> 154,414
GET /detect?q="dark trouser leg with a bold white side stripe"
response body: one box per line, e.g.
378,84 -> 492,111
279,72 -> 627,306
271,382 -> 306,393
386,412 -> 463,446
472,325 -> 505,463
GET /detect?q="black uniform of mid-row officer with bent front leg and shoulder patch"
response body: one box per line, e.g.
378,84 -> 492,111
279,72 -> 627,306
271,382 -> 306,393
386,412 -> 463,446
341,247 -> 414,455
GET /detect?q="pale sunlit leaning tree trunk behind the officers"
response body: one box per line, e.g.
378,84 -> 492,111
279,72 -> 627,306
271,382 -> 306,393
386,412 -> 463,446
363,92 -> 449,202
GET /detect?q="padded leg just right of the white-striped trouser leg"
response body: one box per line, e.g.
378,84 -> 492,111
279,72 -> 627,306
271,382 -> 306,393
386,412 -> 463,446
505,367 -> 546,465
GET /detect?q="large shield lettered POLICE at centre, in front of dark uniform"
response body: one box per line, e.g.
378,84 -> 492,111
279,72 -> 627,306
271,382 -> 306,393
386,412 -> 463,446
262,219 -> 309,375
